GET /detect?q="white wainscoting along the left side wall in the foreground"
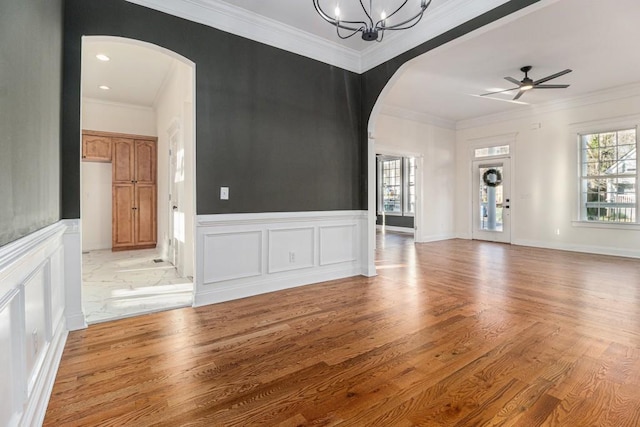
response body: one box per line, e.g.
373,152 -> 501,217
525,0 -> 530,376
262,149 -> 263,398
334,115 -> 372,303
0,222 -> 67,426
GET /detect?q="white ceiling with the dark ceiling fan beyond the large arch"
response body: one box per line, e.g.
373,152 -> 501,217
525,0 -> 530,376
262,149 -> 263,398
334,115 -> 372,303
384,0 -> 640,122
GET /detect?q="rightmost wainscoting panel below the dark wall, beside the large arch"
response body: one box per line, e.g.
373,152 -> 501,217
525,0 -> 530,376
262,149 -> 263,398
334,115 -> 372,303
320,224 -> 359,265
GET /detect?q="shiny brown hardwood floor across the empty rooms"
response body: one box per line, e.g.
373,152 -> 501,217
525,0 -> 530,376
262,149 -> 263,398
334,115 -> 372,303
45,240 -> 640,427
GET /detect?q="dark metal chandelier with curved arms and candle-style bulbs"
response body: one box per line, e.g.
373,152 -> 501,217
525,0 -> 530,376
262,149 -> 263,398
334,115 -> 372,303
313,0 -> 431,42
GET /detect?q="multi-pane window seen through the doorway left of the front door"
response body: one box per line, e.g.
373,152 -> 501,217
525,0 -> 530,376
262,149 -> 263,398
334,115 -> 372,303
378,156 -> 416,215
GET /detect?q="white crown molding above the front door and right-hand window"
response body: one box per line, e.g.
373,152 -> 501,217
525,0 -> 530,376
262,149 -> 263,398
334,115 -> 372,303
456,83 -> 640,130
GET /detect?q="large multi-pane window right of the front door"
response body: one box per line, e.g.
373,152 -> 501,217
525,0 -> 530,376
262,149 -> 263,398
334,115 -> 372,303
580,128 -> 638,223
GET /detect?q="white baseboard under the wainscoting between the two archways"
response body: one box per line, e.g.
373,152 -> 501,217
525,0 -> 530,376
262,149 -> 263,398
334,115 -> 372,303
193,267 -> 361,307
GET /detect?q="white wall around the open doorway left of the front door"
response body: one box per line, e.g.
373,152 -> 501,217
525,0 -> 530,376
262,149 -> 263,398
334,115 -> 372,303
373,114 -> 456,242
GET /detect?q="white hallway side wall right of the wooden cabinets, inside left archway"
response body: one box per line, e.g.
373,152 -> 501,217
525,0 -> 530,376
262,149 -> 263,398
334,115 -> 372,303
156,61 -> 195,276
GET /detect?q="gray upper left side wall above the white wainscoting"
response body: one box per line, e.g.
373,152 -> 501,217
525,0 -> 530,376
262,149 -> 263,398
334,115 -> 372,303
0,0 -> 62,246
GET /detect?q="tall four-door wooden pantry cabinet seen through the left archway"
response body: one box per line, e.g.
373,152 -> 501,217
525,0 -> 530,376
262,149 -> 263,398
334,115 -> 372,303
112,137 -> 157,251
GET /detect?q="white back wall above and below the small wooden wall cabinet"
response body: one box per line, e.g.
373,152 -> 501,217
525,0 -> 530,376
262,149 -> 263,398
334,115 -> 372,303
80,98 -> 156,250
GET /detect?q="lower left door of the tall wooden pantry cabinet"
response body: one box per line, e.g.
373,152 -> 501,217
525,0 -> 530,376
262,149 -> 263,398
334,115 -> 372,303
111,183 -> 135,249
